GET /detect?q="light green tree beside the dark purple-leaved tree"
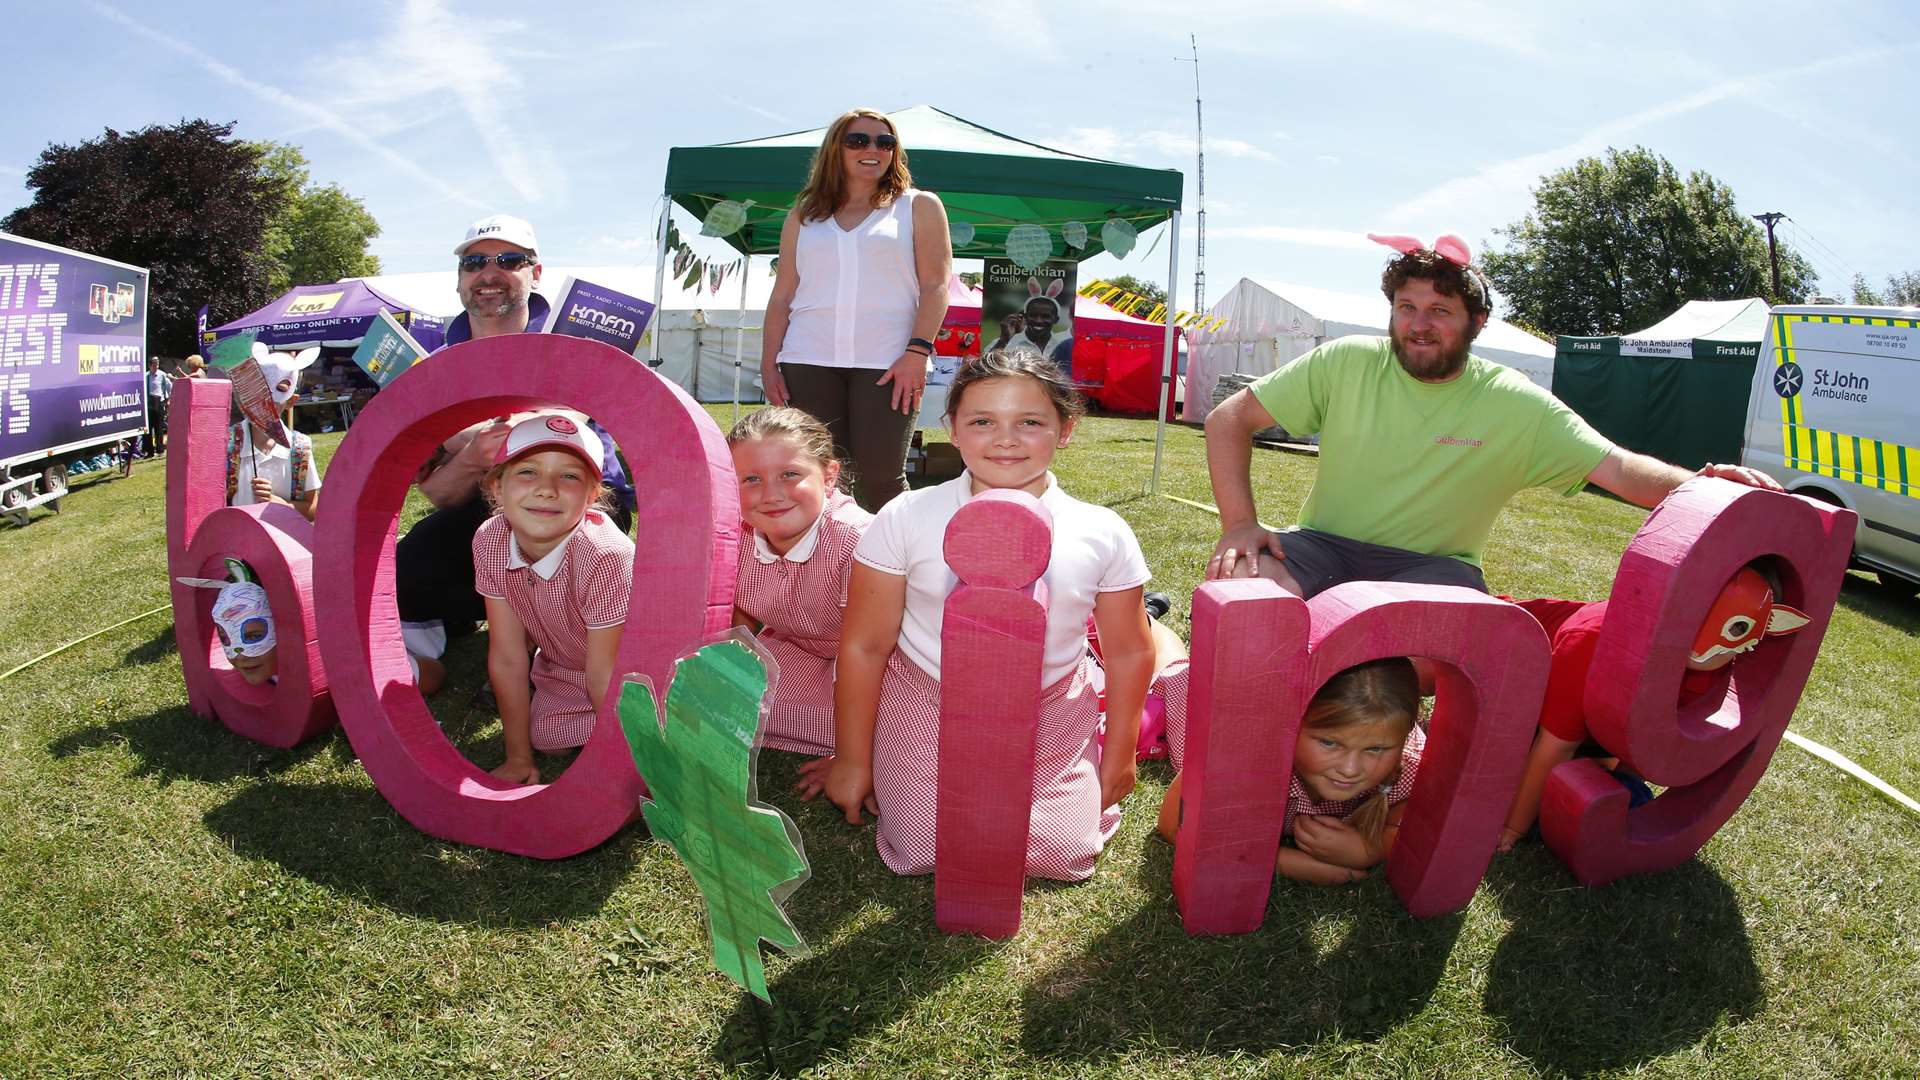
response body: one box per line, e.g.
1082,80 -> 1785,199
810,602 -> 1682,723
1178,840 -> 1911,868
253,142 -> 380,292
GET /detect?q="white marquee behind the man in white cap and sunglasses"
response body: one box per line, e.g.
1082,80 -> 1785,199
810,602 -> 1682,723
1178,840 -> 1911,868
353,259 -> 774,402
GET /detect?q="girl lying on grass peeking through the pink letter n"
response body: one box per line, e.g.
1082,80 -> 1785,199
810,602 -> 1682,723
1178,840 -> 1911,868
1154,657 -> 1427,886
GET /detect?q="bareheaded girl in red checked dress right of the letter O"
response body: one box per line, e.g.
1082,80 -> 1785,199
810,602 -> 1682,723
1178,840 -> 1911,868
726,405 -> 874,753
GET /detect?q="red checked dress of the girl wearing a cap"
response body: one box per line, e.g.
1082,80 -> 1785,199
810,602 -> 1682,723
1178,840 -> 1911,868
474,509 -> 634,749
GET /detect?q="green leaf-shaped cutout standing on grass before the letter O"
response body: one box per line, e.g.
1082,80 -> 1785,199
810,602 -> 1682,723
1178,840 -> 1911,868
620,640 -> 808,1001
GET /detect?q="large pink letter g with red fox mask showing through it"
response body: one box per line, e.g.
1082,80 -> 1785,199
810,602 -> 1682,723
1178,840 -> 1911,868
1536,479 -> 1859,886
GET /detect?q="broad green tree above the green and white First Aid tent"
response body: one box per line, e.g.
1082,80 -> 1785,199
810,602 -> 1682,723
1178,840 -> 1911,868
1482,146 -> 1816,334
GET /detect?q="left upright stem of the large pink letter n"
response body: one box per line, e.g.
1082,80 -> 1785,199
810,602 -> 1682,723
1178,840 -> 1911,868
1173,578 -> 1308,934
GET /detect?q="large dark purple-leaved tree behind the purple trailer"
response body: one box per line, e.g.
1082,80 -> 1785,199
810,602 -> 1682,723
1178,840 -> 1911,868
0,119 -> 282,354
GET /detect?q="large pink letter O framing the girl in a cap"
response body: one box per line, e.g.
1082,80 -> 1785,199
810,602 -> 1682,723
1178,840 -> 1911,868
315,334 -> 739,859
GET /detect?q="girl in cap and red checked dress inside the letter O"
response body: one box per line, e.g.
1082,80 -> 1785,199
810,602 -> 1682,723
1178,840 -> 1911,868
474,415 -> 634,784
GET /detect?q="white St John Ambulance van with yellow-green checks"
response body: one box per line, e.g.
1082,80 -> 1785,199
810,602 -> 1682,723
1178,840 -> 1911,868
1743,306 -> 1920,582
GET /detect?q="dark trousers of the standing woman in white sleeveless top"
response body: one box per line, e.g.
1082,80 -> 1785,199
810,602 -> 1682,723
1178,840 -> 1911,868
780,363 -> 918,513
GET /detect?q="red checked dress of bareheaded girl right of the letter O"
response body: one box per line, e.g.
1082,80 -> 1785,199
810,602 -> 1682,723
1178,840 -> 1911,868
733,492 -> 874,753
